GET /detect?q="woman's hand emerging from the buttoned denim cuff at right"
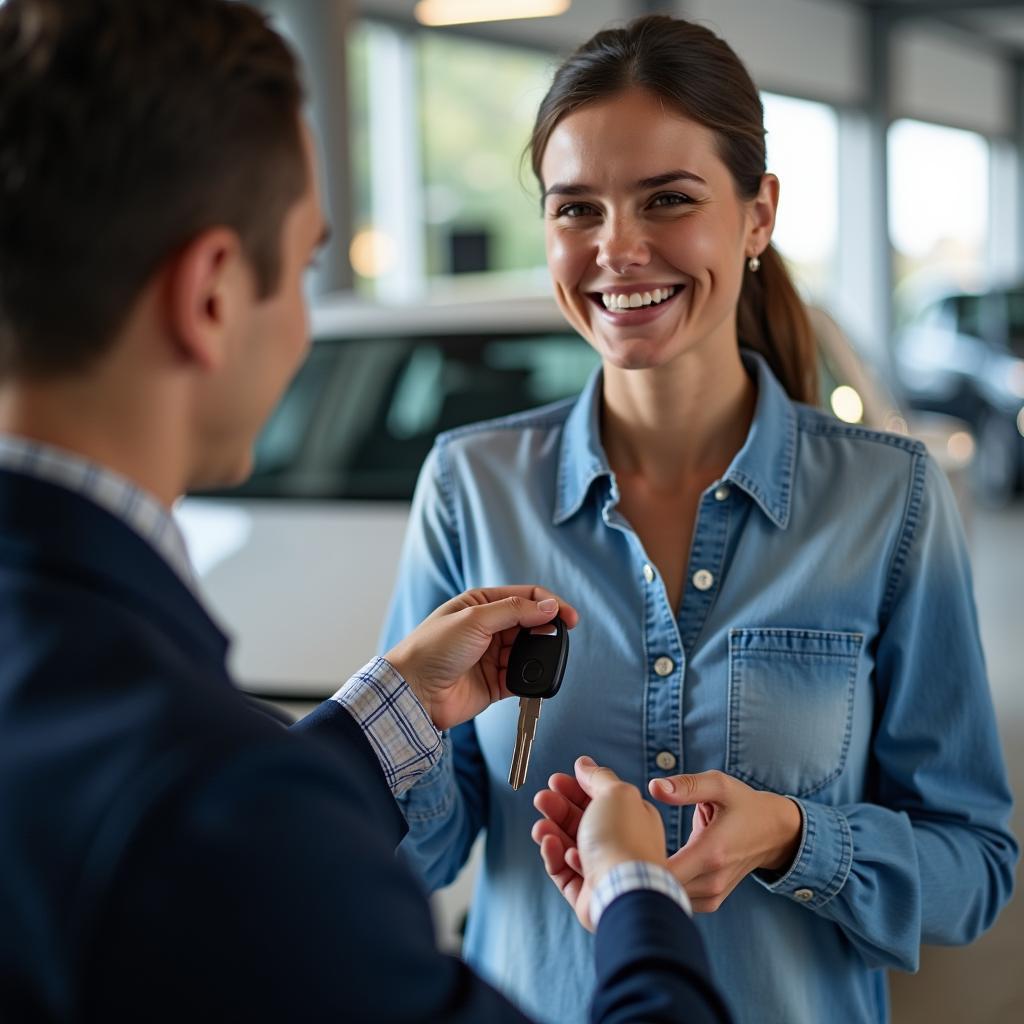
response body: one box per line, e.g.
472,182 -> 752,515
648,771 -> 803,913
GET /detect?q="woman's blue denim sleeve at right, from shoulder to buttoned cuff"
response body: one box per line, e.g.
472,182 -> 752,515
755,456 -> 1018,971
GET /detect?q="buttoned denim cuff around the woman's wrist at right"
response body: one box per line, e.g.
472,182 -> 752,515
754,797 -> 853,909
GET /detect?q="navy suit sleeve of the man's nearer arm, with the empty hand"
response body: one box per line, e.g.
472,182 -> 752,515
76,734 -> 727,1024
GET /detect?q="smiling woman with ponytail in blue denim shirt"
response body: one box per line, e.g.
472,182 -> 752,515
385,16 -> 1017,1024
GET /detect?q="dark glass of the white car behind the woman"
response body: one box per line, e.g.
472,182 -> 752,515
196,332 -> 598,500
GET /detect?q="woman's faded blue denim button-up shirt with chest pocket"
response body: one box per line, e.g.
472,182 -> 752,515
384,354 -> 1017,1024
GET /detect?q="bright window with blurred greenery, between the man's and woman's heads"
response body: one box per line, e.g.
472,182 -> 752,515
348,22 -> 555,296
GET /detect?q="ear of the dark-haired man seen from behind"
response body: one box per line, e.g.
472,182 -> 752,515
167,227 -> 251,370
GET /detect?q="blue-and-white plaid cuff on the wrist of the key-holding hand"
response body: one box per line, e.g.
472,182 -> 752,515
332,657 -> 441,797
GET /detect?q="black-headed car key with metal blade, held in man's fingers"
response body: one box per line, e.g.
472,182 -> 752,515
505,618 -> 569,790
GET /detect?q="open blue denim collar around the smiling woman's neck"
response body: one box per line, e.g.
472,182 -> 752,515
554,349 -> 797,528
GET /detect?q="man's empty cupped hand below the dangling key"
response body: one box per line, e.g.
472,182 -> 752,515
532,757 -> 666,931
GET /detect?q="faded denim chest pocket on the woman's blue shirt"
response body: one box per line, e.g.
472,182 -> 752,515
725,629 -> 864,797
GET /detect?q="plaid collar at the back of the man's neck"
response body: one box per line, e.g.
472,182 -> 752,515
0,434 -> 197,591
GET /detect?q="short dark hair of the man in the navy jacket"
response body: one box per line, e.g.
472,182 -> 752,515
0,0 -> 308,377
